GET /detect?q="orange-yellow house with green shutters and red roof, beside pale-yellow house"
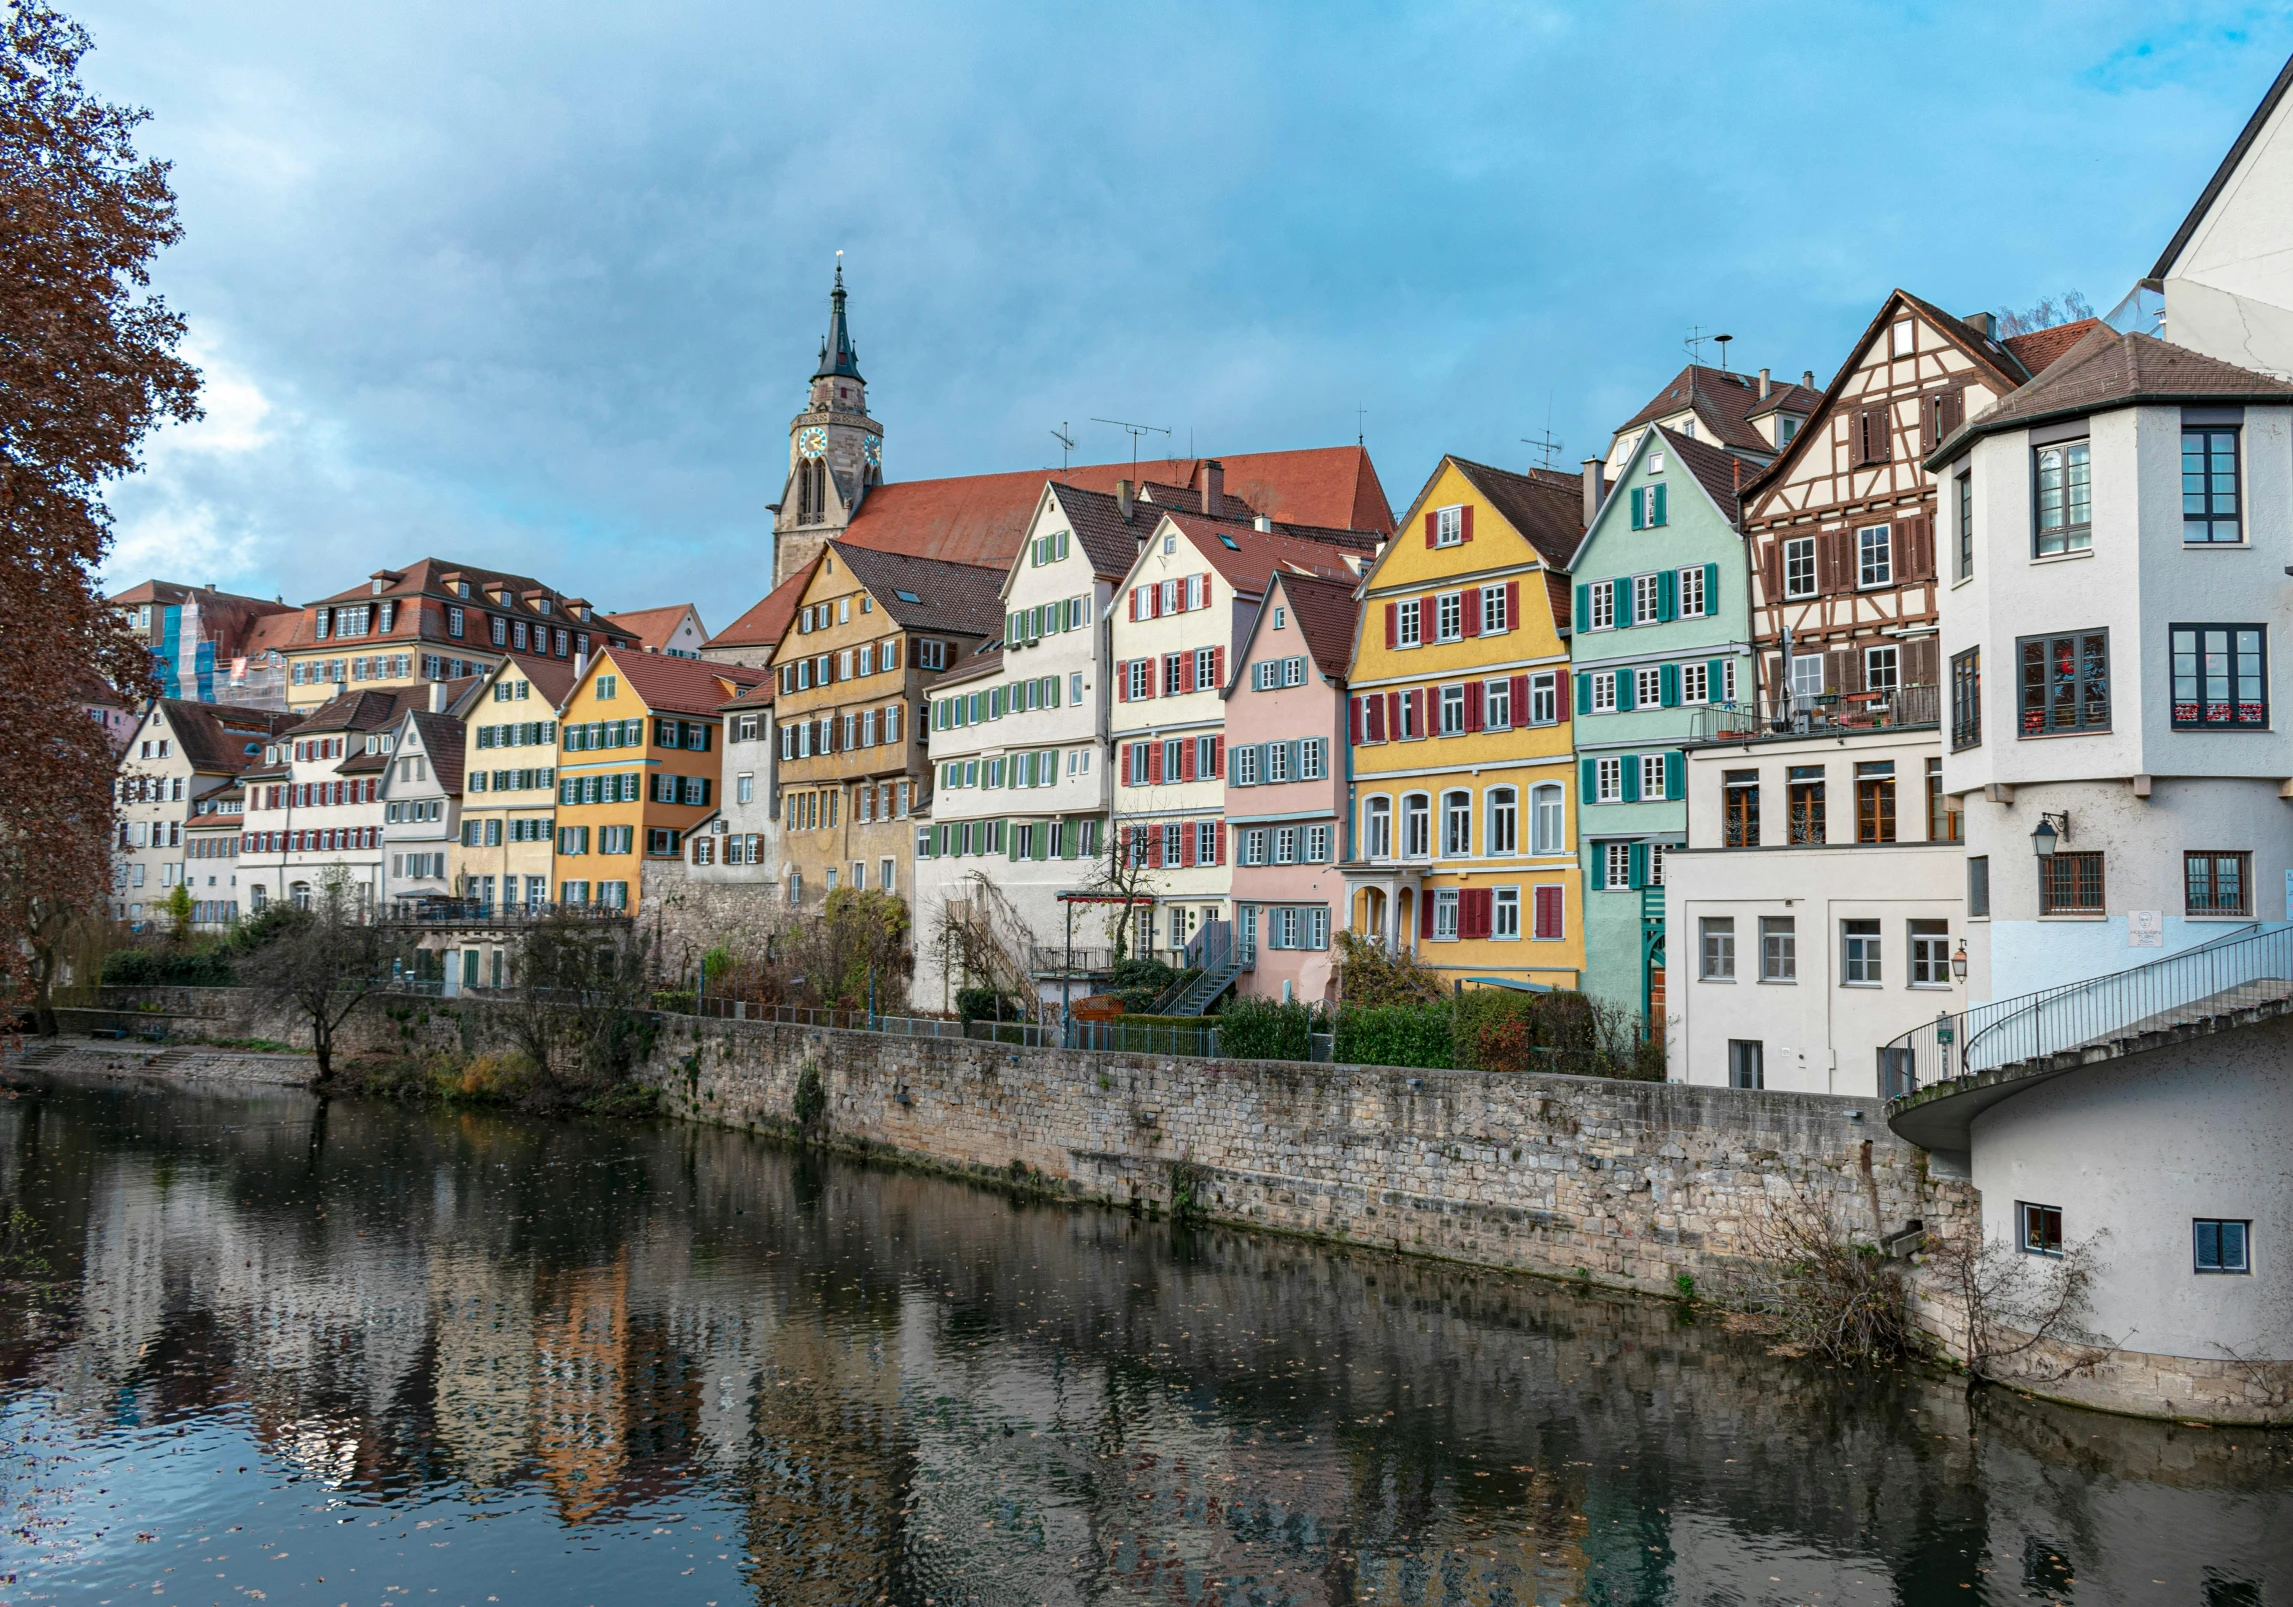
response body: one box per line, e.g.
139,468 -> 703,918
554,649 -> 766,912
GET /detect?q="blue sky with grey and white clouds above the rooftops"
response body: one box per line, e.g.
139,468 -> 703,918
76,0 -> 2293,626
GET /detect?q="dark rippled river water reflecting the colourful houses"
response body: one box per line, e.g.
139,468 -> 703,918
0,1082 -> 2293,1607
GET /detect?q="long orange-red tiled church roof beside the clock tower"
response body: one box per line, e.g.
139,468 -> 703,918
839,447 -> 1394,569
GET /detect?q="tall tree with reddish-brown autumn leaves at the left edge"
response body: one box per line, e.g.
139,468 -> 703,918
0,0 -> 199,1029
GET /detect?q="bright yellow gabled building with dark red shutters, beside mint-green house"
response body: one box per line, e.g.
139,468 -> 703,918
1341,456 -> 1598,988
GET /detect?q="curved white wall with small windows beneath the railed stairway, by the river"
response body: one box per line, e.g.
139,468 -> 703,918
1972,1020 -> 2293,1362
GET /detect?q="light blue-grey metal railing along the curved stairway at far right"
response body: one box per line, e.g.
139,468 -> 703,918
1878,926 -> 2293,1098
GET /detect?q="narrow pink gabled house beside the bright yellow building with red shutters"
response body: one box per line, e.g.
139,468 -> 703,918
1222,571 -> 1355,1004
